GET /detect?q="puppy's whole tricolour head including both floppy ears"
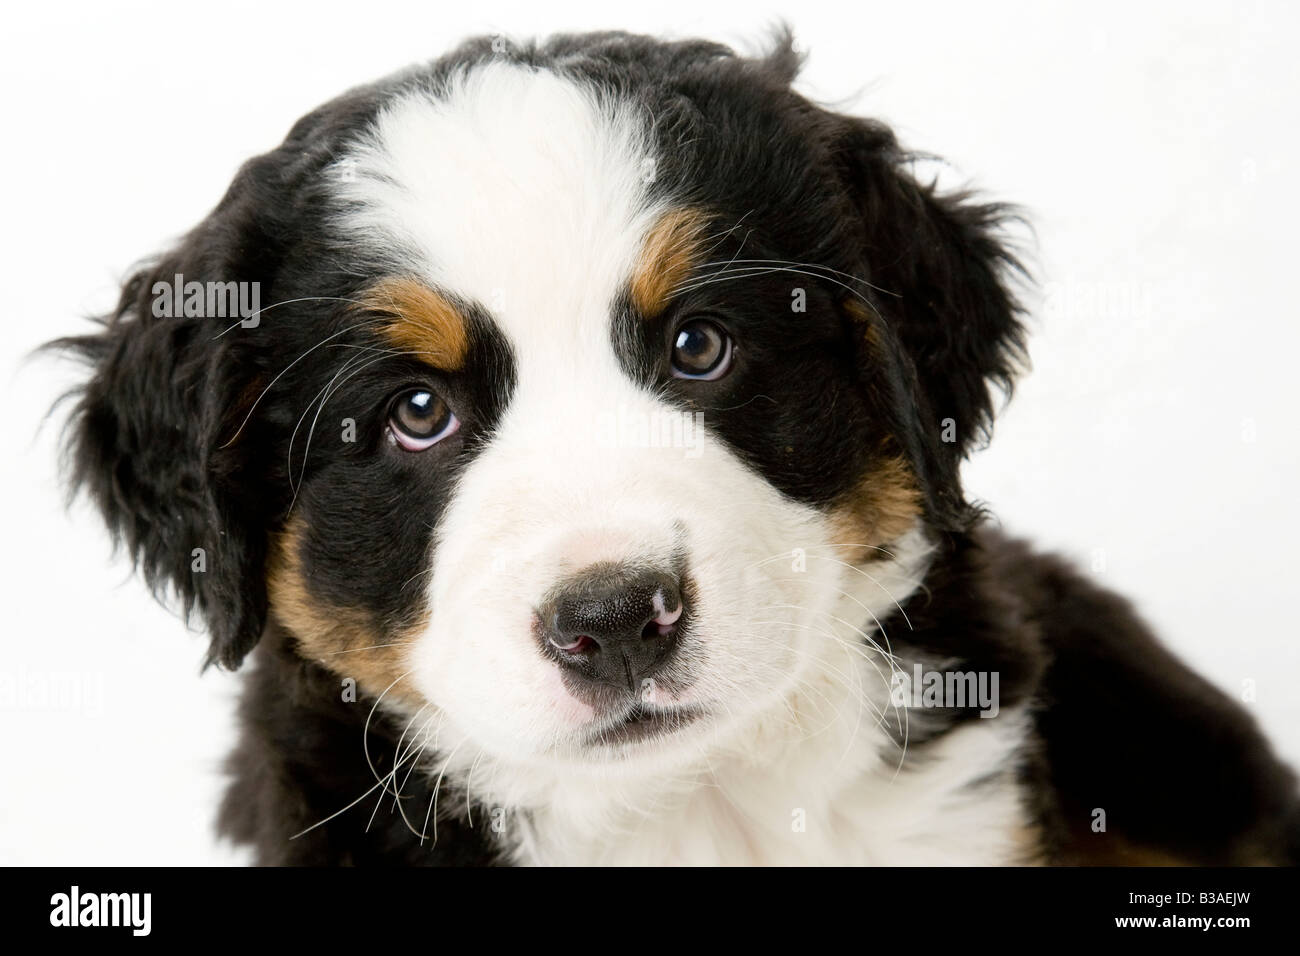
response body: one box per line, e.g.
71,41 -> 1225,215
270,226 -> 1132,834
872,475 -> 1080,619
55,35 -> 1021,773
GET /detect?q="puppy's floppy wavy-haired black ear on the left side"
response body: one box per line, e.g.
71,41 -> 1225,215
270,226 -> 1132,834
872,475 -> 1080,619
47,156 -> 292,669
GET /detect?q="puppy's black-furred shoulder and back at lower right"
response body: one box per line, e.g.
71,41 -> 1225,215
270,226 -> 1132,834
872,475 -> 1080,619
980,532 -> 1300,865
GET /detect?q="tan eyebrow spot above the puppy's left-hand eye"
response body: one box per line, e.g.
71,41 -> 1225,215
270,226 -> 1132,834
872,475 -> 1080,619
361,277 -> 469,371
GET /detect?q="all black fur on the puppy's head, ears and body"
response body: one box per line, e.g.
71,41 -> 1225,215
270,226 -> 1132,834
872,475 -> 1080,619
53,34 -> 1300,864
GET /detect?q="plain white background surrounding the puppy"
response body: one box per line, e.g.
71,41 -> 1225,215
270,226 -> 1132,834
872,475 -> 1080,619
0,0 -> 1300,864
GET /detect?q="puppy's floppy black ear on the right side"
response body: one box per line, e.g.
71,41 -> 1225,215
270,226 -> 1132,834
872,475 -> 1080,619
836,117 -> 1024,528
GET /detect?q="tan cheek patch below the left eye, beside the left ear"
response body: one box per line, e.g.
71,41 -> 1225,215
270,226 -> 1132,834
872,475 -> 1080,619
267,519 -> 425,706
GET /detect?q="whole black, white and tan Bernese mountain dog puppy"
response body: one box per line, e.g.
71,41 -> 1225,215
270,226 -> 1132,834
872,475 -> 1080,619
56,34 -> 1300,865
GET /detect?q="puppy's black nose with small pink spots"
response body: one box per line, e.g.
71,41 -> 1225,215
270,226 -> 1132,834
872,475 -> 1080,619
538,564 -> 686,691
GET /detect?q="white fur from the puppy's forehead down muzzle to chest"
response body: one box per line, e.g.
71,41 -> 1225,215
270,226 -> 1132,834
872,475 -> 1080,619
343,62 -> 1021,864
